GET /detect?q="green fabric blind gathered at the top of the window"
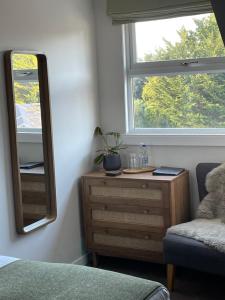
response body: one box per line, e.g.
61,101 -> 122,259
107,0 -> 212,24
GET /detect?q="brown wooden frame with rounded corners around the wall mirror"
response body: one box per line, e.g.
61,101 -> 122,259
4,50 -> 57,234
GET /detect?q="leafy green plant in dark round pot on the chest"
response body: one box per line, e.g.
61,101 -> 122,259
94,127 -> 126,171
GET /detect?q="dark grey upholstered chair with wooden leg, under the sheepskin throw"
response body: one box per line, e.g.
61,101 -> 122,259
163,163 -> 225,291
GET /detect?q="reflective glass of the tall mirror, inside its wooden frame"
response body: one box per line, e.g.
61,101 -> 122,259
12,53 -> 47,226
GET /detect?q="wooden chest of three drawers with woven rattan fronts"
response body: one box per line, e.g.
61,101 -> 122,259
82,172 -> 189,263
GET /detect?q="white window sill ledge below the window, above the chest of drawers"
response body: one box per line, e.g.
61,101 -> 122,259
123,133 -> 225,147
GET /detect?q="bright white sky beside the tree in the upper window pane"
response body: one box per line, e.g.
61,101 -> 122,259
135,14 -> 209,61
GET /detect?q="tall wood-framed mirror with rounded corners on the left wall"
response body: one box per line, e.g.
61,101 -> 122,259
5,51 -> 56,234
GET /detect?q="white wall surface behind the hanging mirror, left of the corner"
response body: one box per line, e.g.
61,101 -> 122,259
0,0 -> 98,262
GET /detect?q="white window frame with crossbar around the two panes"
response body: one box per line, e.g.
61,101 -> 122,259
123,18 -> 225,136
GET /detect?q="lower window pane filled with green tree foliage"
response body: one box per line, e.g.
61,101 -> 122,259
132,73 -> 225,129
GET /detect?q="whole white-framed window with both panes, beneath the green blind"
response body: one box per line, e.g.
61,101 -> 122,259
126,14 -> 225,134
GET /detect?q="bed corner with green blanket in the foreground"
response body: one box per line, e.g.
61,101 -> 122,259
0,256 -> 169,300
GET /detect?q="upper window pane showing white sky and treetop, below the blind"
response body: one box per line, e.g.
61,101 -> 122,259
135,14 -> 225,62
